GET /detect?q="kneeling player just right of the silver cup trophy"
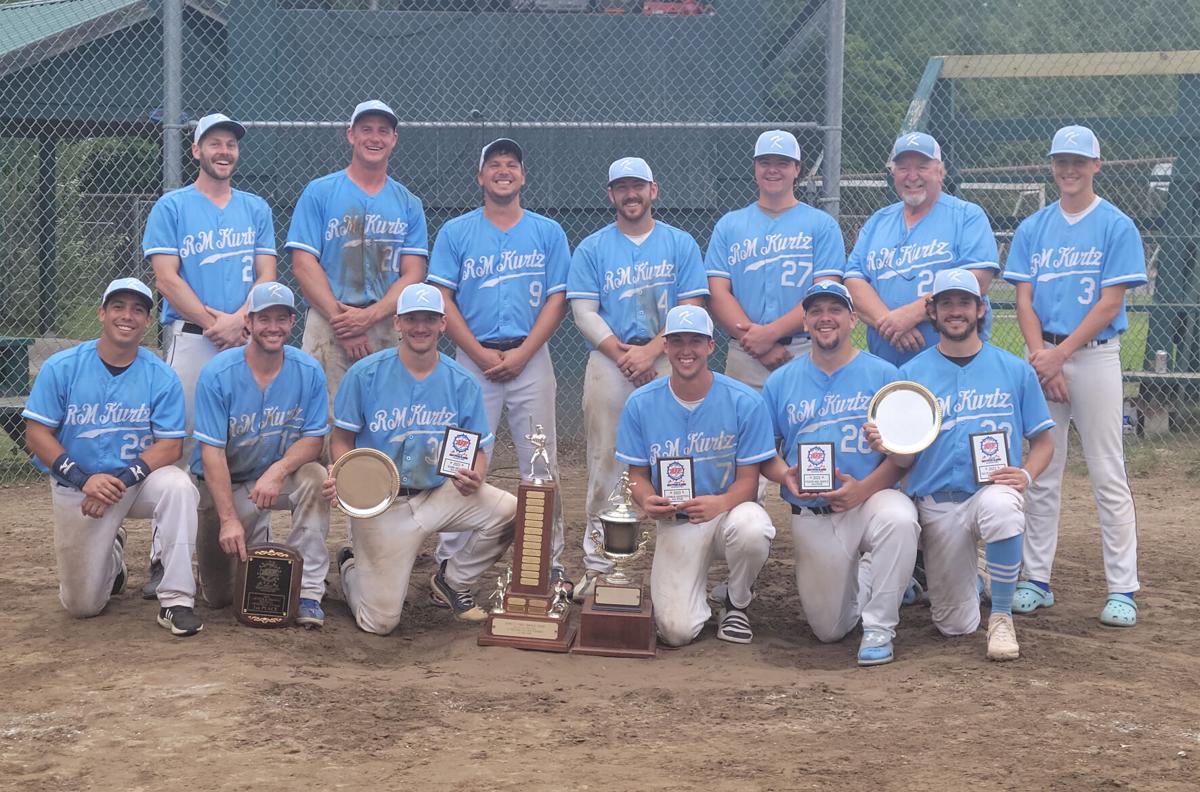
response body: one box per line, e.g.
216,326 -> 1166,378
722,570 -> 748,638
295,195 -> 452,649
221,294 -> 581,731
616,305 -> 775,646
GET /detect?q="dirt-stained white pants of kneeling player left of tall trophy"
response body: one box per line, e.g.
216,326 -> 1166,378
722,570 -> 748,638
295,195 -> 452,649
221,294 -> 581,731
342,482 -> 517,635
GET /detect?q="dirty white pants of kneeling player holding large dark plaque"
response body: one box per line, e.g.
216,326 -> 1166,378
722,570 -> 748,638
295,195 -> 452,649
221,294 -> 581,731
196,462 -> 329,607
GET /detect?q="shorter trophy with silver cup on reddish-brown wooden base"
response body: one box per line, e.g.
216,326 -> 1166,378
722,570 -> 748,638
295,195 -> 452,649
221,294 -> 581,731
571,473 -> 658,658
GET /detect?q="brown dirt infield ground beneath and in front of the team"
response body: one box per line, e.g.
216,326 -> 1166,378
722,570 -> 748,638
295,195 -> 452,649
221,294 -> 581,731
0,458 -> 1200,792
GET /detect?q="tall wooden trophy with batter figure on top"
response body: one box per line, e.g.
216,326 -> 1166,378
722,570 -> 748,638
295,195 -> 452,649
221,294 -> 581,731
479,421 -> 575,652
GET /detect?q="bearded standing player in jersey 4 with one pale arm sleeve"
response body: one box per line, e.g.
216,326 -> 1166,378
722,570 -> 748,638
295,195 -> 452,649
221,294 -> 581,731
566,157 -> 708,602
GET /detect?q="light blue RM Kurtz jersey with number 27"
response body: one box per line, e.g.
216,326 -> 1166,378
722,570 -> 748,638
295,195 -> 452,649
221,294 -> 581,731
704,204 -> 846,324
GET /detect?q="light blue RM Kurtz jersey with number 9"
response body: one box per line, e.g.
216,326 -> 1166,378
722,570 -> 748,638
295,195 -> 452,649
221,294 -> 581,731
427,209 -> 571,341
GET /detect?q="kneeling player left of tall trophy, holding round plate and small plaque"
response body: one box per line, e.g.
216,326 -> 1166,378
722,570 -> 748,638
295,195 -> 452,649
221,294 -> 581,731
324,283 -> 516,635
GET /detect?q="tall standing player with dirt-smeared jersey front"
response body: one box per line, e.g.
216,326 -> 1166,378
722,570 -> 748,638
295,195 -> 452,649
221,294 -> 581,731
284,100 -> 428,400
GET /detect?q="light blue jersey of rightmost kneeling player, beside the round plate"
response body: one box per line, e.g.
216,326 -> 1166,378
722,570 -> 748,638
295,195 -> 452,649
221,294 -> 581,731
900,343 -> 1054,497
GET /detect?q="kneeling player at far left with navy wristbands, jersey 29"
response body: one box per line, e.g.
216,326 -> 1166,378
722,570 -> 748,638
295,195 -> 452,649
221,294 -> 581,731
22,277 -> 204,636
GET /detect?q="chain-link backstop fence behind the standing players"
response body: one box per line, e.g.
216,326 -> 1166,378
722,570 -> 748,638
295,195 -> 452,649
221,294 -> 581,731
0,0 -> 1200,481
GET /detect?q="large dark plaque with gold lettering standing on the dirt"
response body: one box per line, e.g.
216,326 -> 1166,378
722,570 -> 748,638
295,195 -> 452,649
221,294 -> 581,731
234,544 -> 304,628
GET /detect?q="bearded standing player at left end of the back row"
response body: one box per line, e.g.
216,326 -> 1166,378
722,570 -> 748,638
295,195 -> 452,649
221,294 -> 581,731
142,113 -> 276,599
